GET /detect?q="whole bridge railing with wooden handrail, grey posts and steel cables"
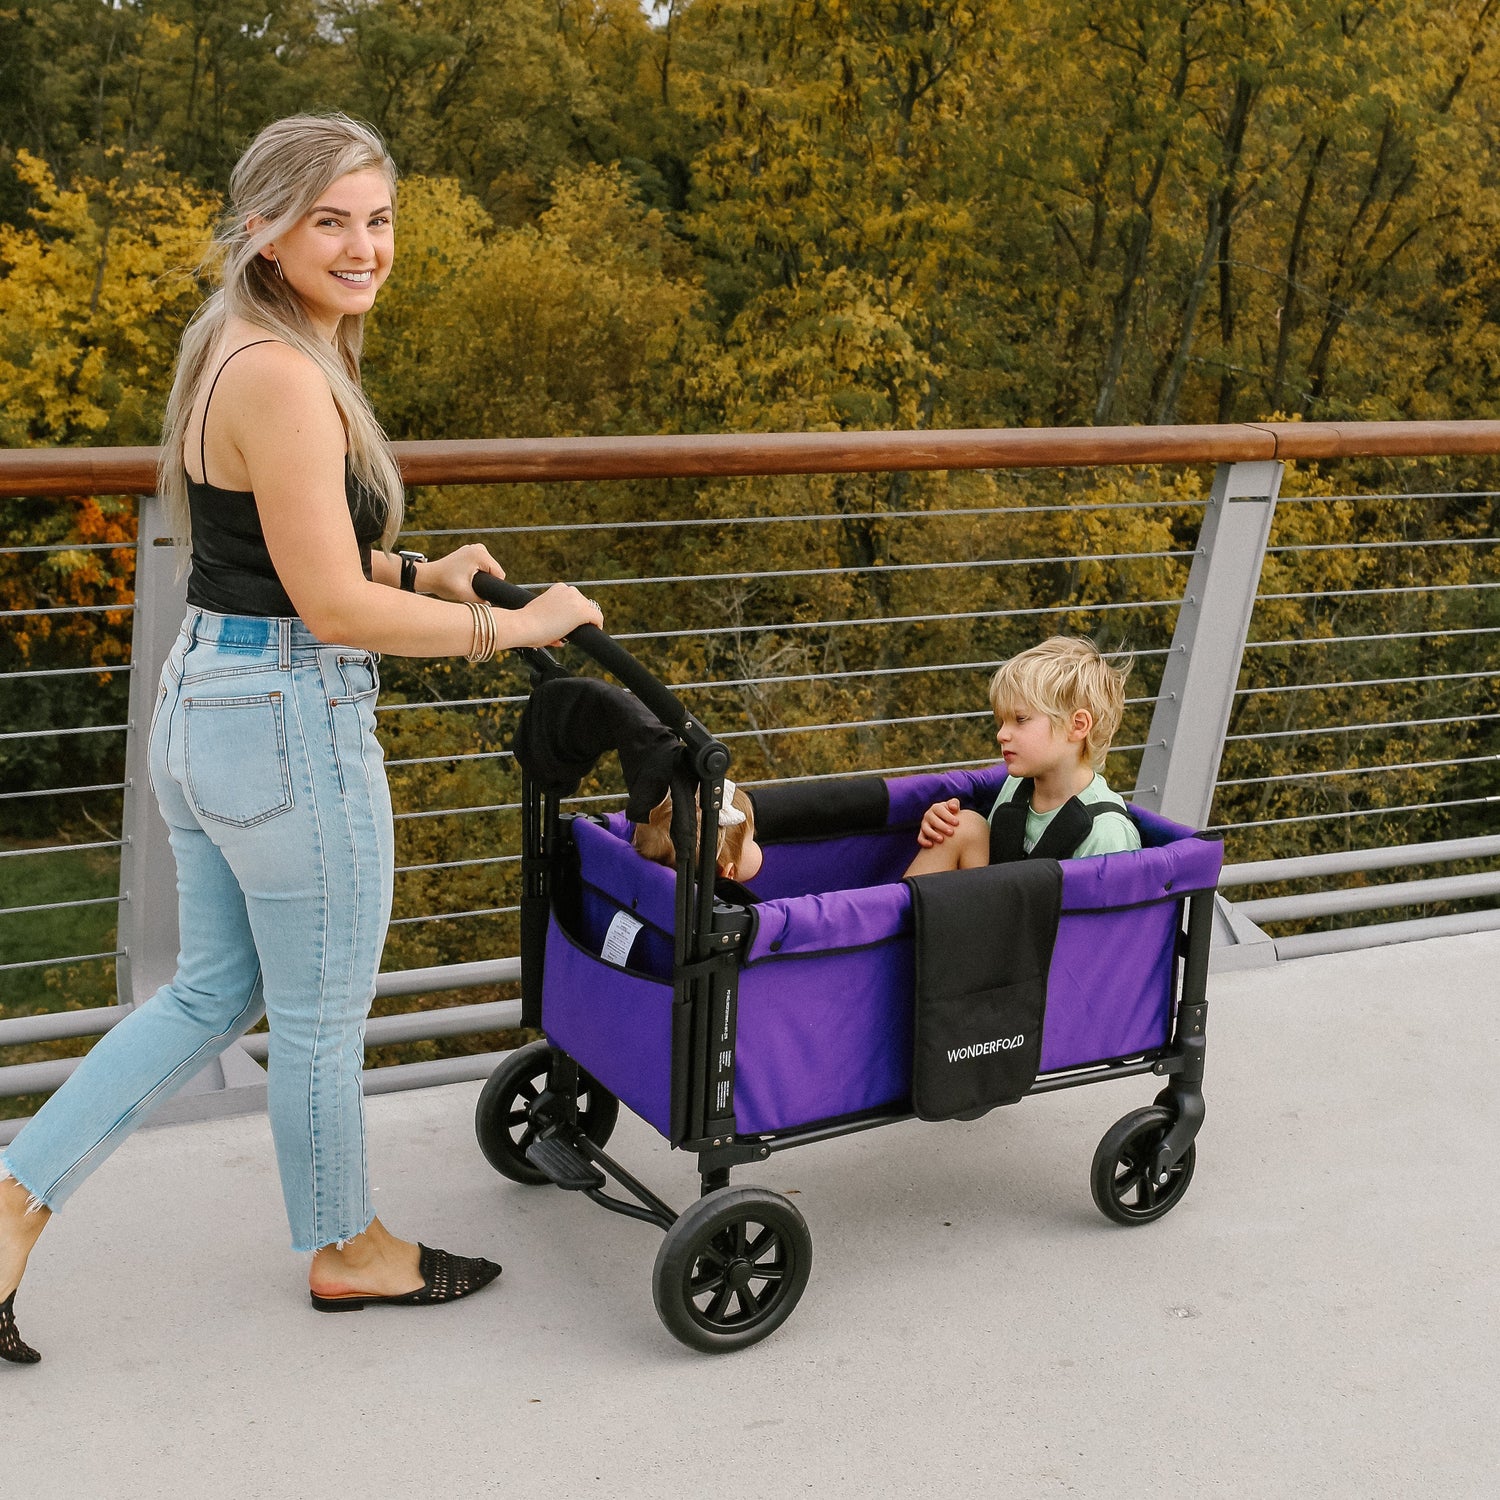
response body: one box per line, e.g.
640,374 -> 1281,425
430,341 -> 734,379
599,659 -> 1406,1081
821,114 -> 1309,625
0,423 -> 1500,1139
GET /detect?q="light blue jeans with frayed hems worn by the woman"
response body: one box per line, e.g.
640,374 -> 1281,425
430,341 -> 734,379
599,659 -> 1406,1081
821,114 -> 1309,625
0,609 -> 393,1251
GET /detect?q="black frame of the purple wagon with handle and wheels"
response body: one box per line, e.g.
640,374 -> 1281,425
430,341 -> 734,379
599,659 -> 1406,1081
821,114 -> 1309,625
474,575 -> 1214,1353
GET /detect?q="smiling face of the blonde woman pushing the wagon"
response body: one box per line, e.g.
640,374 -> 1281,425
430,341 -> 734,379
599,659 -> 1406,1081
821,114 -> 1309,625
261,170 -> 396,339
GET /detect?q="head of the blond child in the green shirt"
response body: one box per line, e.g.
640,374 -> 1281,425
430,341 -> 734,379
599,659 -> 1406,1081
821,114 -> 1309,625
990,636 -> 1131,776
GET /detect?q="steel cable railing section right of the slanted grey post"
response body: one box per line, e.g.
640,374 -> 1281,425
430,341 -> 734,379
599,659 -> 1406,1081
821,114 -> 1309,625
1215,491 -> 1500,956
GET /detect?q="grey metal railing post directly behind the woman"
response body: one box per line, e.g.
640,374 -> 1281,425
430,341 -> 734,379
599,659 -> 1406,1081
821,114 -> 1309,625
116,495 -> 266,1121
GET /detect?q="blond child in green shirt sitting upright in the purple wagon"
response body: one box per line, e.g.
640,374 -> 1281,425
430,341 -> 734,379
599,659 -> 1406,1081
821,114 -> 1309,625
906,636 -> 1140,875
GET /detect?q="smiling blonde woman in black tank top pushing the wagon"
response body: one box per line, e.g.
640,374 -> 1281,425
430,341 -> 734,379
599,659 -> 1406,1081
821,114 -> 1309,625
0,116 -> 602,1364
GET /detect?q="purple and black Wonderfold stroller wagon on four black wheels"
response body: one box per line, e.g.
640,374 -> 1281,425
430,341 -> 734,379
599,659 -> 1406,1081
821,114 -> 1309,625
476,575 -> 1223,1353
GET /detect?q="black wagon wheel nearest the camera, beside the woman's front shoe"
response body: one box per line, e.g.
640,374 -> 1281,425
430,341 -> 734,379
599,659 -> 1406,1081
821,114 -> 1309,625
651,1188 -> 813,1355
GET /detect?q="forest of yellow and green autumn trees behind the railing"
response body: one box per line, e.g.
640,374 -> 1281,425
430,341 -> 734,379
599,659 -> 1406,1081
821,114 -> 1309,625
0,0 -> 1500,1092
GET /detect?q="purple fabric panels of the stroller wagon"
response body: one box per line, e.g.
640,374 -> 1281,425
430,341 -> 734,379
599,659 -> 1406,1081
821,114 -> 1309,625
543,767 -> 1223,1134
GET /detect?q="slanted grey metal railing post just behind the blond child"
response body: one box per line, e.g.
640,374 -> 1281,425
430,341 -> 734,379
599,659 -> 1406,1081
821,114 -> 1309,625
1136,461 -> 1283,828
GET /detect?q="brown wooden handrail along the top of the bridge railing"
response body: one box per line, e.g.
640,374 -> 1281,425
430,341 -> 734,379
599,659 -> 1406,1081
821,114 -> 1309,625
0,422 -> 1500,495
